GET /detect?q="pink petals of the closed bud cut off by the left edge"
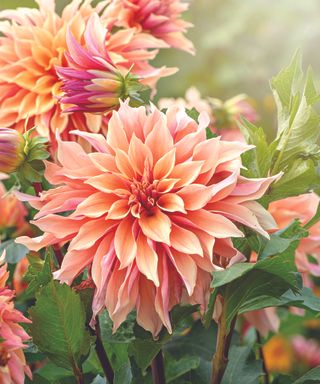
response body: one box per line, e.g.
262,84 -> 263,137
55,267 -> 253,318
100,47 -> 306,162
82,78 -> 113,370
0,128 -> 25,173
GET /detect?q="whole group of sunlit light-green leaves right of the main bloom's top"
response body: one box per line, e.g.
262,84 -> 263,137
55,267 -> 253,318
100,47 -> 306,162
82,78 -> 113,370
240,53 -> 320,204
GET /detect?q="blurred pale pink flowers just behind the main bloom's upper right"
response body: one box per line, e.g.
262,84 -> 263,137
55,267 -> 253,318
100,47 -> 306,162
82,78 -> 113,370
158,87 -> 258,142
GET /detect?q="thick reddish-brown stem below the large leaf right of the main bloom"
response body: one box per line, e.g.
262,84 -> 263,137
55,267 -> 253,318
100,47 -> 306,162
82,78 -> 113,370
211,308 -> 237,384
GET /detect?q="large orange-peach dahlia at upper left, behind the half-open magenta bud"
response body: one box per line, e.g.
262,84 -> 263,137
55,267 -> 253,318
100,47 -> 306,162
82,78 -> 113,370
0,0 -> 175,142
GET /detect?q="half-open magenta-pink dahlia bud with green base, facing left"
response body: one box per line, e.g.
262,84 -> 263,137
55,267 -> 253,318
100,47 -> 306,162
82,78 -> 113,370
56,14 -> 146,112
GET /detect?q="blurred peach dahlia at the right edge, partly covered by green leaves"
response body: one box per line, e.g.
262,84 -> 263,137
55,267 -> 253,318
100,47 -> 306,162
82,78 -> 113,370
269,193 -> 320,280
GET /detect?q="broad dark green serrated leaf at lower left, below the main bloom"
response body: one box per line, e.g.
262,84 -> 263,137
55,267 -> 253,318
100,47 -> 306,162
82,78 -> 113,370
29,281 -> 90,370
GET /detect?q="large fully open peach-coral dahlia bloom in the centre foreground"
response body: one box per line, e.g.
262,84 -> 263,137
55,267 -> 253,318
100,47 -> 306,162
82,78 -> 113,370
17,102 -> 275,335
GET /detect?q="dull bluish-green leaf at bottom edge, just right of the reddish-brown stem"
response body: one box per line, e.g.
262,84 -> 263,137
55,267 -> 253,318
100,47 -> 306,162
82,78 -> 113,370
222,345 -> 263,384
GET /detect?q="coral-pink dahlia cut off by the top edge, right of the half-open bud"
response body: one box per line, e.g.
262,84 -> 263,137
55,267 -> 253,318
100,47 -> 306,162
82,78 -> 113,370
104,0 -> 194,54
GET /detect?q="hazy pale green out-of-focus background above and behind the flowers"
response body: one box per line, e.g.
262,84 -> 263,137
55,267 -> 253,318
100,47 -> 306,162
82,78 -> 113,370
0,0 -> 320,132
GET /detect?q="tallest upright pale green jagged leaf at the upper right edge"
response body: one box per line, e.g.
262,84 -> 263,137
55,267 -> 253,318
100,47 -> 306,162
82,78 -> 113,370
271,53 -> 320,174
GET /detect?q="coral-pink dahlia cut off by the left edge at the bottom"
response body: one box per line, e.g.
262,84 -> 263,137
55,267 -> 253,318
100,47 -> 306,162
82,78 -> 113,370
0,264 -> 31,384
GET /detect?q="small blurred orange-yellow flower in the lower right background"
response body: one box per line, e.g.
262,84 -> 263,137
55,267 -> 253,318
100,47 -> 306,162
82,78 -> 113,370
263,335 -> 293,373
